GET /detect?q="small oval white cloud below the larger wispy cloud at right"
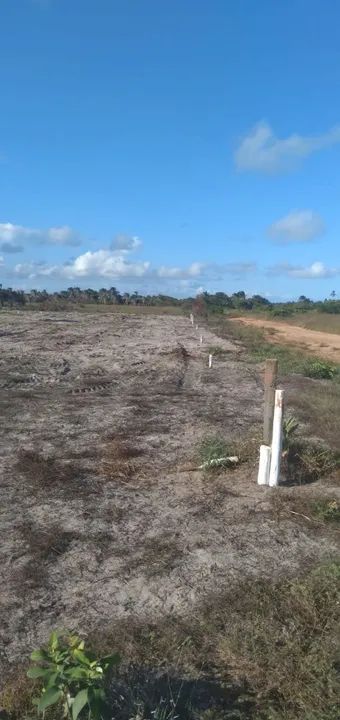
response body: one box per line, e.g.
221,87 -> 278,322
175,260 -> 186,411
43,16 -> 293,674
268,210 -> 325,244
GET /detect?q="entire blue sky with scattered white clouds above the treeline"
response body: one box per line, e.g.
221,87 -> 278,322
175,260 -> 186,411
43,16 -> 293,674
0,0 -> 340,299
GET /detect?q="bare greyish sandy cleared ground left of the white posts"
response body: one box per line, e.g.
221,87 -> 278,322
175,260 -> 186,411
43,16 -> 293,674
0,311 -> 340,680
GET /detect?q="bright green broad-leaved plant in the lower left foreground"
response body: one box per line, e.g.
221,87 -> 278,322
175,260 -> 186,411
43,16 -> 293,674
27,632 -> 120,720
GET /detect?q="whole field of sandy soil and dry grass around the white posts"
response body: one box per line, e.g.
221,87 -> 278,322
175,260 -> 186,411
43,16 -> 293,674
0,312 -> 340,720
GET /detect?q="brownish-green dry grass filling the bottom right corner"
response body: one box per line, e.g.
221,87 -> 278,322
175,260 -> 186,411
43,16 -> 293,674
86,564 -> 340,720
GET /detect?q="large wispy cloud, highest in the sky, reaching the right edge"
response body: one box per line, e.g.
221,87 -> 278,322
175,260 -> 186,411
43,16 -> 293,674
235,122 -> 340,173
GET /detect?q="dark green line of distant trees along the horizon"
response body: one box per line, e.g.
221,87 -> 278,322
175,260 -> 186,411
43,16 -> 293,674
0,285 -> 340,317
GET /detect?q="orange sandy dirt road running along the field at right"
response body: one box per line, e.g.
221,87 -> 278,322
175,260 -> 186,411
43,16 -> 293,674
232,317 -> 340,363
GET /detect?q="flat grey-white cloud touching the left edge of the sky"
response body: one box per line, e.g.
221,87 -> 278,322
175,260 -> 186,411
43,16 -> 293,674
0,223 -> 80,252
